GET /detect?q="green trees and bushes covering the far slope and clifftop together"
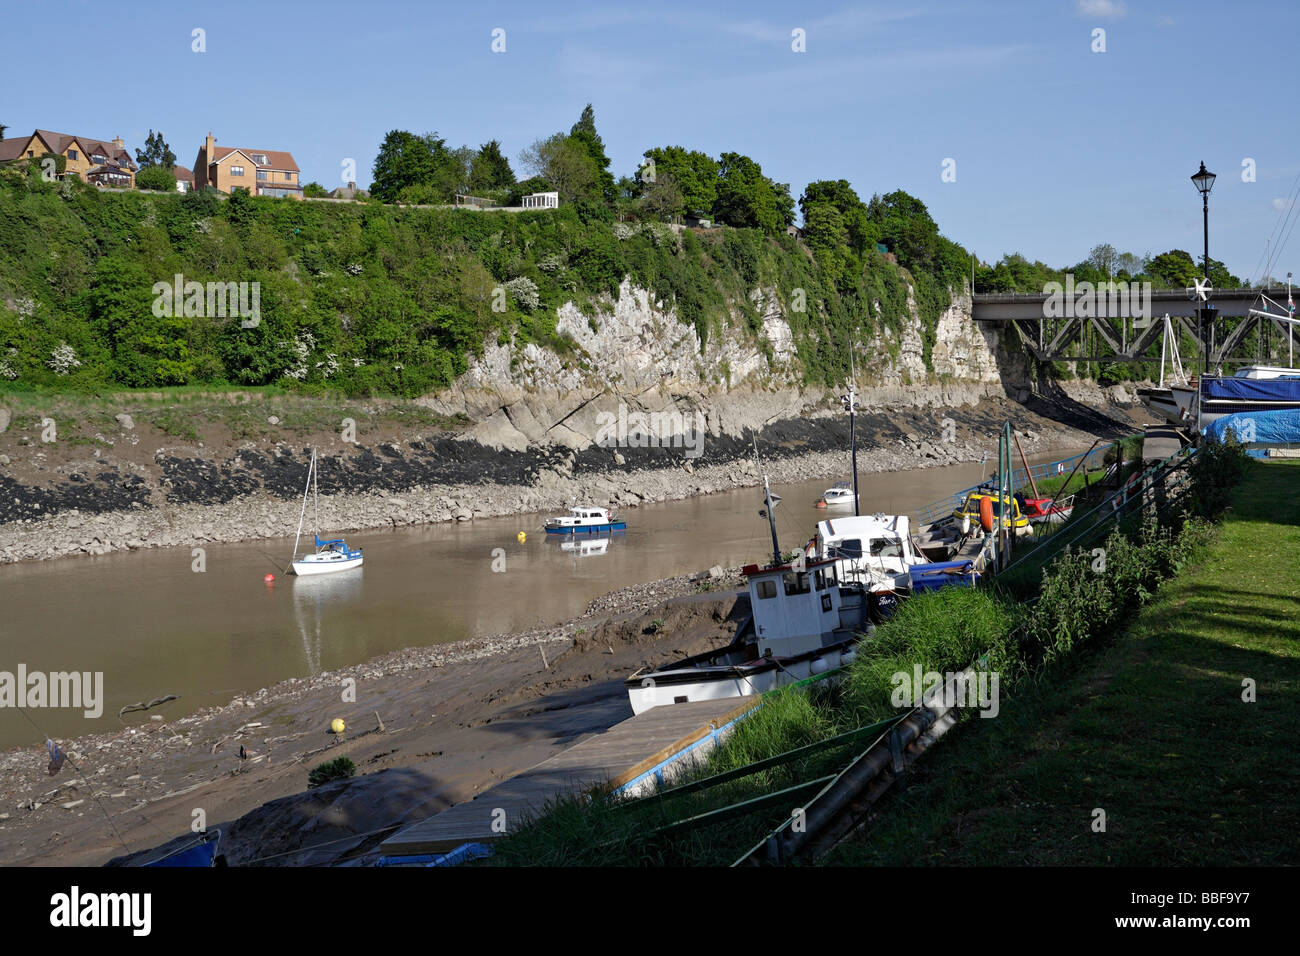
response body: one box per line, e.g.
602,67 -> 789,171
0,107 -> 1182,398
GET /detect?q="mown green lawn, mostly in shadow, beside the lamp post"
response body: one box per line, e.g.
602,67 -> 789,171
826,462 -> 1300,866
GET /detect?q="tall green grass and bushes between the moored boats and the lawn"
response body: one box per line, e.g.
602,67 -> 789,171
494,444 -> 1244,865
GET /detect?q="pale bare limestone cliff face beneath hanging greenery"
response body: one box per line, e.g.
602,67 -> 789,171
429,273 -> 1023,450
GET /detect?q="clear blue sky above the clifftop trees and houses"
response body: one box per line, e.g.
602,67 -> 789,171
10,0 -> 1300,278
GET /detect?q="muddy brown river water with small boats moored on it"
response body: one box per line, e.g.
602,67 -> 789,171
0,451 -> 1071,748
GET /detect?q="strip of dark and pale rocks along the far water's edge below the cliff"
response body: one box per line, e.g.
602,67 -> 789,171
0,389 -> 1147,563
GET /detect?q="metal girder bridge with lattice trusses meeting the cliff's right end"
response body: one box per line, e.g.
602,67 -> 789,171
972,282 -> 1300,367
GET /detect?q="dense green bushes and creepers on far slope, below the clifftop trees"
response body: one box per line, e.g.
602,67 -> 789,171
0,162 -> 967,397
